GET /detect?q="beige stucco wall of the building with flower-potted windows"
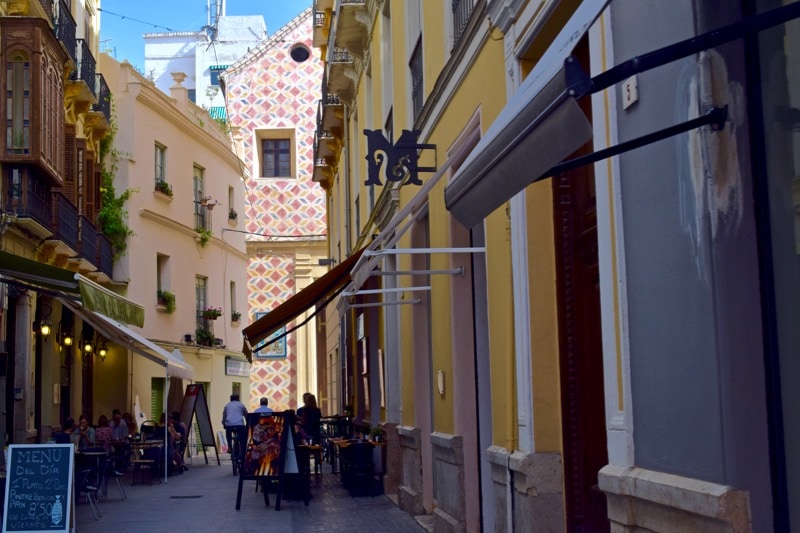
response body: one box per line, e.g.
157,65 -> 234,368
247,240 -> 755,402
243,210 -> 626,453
95,54 -> 249,429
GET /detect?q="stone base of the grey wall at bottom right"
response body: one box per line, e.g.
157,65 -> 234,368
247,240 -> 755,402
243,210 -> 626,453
599,465 -> 752,533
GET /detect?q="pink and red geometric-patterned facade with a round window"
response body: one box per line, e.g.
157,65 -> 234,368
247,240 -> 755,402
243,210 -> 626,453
224,9 -> 327,410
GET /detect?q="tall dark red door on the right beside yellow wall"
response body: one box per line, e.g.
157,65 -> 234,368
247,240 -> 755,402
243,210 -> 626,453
552,40 -> 609,533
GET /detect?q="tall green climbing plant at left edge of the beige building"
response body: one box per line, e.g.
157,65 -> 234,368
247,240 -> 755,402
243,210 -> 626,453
97,99 -> 138,261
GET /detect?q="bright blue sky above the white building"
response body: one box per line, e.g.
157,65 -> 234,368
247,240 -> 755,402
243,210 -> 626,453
100,0 -> 312,71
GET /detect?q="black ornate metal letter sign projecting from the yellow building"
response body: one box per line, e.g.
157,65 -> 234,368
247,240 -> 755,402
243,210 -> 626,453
364,130 -> 436,185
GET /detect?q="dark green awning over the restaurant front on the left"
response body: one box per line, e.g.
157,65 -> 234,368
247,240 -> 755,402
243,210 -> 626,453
0,251 -> 144,327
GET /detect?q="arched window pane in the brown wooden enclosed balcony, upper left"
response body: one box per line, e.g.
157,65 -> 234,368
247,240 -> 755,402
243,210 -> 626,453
6,52 -> 31,154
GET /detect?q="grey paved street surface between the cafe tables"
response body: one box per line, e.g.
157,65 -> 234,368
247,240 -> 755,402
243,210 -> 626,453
75,452 -> 425,533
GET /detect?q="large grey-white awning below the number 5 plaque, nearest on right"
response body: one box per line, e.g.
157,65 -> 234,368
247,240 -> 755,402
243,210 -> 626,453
444,0 -> 610,228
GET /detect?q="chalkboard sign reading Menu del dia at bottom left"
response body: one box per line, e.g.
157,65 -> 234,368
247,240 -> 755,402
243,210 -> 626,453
3,444 -> 74,532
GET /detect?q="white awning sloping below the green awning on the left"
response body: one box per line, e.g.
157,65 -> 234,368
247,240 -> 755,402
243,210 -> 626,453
58,298 -> 194,379
